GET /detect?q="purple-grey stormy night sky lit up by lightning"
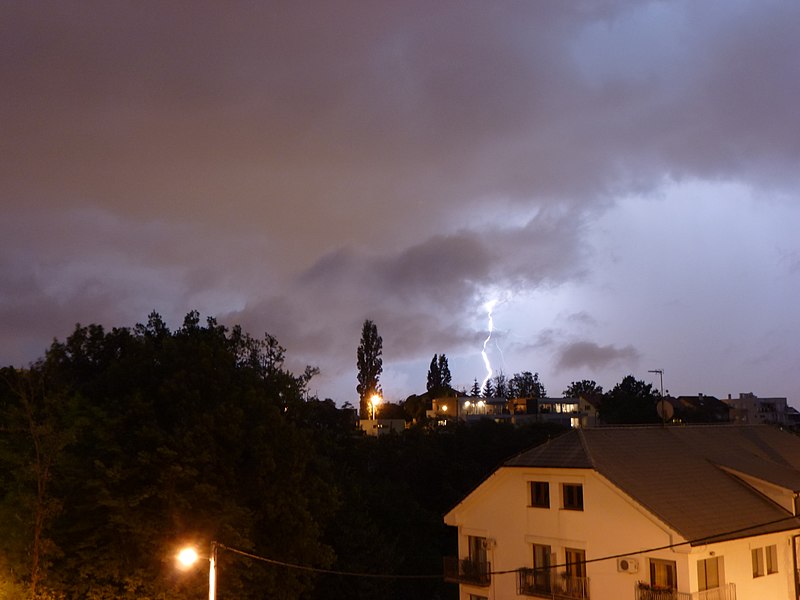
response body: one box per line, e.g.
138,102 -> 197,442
0,0 -> 800,406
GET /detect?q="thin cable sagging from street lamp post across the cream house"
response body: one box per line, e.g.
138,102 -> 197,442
217,515 -> 798,579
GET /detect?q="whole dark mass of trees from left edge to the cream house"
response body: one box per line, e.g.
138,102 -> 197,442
0,312 -> 559,600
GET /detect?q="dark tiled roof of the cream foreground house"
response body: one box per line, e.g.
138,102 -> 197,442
504,425 -> 800,543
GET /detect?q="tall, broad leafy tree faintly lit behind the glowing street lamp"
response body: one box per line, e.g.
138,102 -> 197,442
0,312 -> 336,599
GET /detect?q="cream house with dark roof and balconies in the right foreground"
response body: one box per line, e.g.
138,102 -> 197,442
445,425 -> 800,600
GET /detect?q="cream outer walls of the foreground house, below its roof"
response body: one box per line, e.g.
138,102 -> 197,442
445,467 -> 798,600
